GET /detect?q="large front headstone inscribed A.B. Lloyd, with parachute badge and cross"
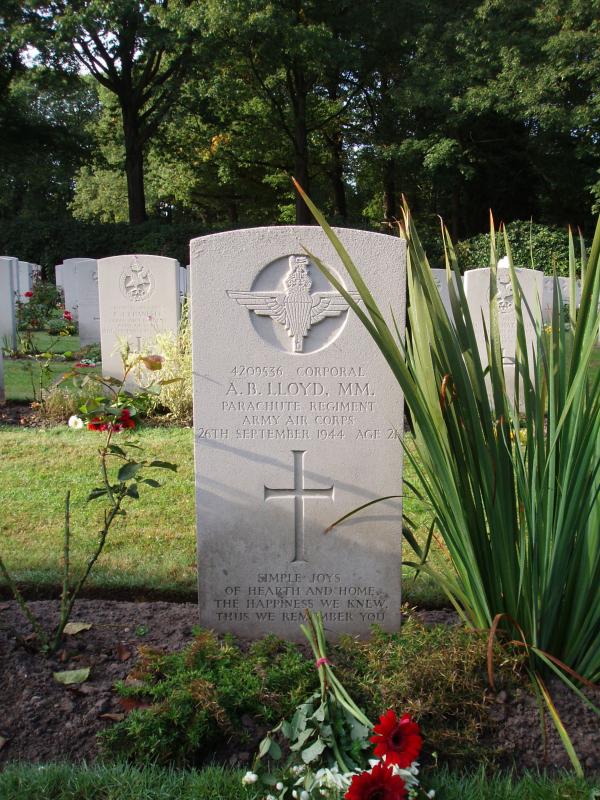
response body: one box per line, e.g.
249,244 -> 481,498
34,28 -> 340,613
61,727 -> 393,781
190,226 -> 406,639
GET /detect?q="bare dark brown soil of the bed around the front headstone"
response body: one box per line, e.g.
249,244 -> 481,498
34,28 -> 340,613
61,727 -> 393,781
0,600 -> 600,773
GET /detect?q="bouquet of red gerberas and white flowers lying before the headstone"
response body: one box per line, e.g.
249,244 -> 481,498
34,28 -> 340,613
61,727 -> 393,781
242,611 -> 433,800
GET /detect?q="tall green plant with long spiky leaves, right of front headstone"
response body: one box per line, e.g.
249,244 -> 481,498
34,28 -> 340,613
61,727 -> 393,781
297,186 -> 600,774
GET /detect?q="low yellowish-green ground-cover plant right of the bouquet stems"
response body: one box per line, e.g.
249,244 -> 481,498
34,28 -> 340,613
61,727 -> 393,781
332,616 -> 508,765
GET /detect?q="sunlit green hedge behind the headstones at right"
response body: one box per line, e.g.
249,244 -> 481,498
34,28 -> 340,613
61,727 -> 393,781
454,221 -> 584,275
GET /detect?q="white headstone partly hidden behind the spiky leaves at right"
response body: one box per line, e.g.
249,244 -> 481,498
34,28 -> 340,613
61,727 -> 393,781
463,262 -> 544,406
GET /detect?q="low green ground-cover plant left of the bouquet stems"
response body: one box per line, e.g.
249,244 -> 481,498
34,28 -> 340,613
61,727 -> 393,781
101,631 -> 317,766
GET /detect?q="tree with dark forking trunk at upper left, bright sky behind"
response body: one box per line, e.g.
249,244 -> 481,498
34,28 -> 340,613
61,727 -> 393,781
33,0 -> 191,224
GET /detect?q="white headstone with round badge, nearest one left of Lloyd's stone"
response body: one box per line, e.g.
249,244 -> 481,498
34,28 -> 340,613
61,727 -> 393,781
97,255 -> 180,378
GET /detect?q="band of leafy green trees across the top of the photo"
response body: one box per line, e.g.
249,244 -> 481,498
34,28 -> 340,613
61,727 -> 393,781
0,0 -> 600,238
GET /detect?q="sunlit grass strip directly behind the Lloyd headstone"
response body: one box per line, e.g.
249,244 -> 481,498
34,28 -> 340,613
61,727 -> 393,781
0,426 -> 445,604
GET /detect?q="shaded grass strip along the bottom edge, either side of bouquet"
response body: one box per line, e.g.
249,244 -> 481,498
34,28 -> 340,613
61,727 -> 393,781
0,764 -> 600,800
